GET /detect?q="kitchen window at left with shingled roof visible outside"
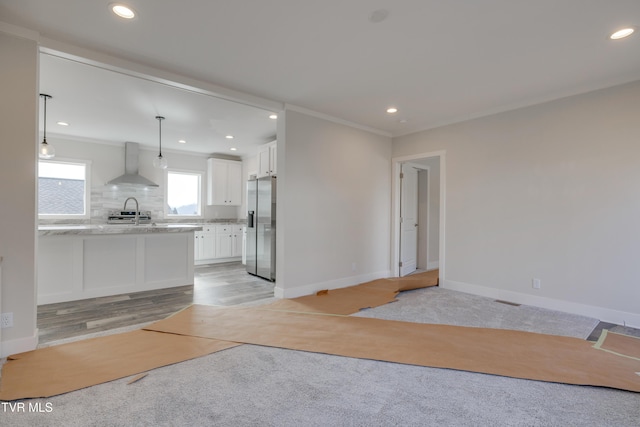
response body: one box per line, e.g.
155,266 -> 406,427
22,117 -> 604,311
38,160 -> 90,219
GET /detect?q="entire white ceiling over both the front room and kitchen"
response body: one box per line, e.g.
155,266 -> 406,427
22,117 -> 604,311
0,0 -> 640,154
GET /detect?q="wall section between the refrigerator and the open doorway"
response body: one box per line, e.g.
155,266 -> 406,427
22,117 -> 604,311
276,110 -> 391,297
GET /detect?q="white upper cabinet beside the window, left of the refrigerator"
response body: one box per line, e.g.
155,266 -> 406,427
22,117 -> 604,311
207,159 -> 242,206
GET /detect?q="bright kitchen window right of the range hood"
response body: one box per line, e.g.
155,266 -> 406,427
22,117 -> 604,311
166,171 -> 202,217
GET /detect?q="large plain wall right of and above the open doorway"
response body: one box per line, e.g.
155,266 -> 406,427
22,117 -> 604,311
393,81 -> 640,327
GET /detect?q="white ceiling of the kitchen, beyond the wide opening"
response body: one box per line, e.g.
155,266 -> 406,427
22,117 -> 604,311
40,54 -> 277,157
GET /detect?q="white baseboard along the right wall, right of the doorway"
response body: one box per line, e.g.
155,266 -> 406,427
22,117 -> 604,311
440,280 -> 640,328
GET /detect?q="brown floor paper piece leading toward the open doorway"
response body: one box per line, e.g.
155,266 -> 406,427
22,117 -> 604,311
265,270 -> 438,315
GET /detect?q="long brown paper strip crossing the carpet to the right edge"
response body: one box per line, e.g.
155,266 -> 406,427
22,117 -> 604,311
145,305 -> 640,392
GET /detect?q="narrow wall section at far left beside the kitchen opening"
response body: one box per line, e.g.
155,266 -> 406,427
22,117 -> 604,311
0,31 -> 39,356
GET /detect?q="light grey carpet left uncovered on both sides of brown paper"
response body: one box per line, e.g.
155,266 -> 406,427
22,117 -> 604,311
0,289 -> 640,427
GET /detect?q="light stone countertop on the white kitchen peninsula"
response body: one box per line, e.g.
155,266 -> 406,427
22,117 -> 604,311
38,223 -> 202,236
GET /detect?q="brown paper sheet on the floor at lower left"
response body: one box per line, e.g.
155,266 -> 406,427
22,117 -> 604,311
0,331 -> 239,400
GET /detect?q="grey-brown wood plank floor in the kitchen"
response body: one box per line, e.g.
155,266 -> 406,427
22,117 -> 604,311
38,262 -> 274,344
